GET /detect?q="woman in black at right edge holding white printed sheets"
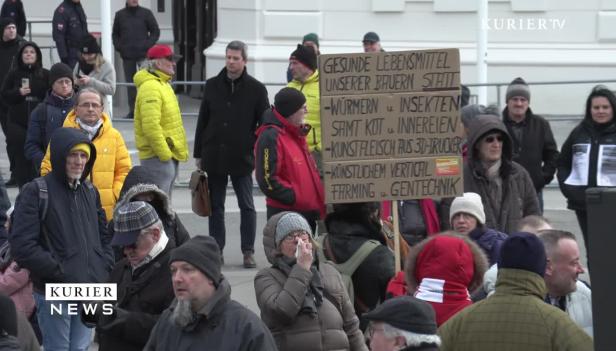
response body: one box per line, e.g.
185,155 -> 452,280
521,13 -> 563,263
558,85 -> 616,252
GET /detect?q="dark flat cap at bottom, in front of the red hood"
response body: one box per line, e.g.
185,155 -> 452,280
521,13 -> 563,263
362,296 -> 436,335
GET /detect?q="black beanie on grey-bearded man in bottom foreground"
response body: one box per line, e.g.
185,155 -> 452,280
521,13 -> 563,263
169,235 -> 222,286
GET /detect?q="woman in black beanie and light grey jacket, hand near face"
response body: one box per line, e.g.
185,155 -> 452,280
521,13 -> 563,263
73,34 -> 116,111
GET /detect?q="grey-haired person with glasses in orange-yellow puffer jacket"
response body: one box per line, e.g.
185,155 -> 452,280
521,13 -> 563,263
41,88 -> 131,221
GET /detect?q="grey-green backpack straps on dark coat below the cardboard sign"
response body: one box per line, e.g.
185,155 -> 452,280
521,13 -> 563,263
317,233 -> 381,304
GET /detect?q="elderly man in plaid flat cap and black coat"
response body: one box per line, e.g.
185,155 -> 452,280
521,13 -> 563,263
85,201 -> 175,351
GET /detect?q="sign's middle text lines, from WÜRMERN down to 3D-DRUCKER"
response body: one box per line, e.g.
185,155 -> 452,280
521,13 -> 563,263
321,92 -> 463,161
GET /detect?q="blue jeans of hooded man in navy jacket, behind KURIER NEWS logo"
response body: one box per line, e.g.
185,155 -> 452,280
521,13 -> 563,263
33,293 -> 92,351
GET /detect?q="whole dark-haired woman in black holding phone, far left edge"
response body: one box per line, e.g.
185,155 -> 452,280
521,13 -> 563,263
1,42 -> 49,188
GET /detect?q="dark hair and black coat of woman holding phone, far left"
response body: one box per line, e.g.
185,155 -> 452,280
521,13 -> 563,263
0,43 -> 49,131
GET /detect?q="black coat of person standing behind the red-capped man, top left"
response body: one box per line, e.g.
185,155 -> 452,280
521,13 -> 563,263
111,6 -> 160,60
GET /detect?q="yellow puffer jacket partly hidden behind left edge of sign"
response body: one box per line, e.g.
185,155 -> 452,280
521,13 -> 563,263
287,71 -> 322,151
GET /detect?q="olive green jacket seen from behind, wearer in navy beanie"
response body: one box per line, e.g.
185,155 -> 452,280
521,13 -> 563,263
439,268 -> 593,351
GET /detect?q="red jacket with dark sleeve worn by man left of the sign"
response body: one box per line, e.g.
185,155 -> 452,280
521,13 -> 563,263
255,108 -> 325,217
